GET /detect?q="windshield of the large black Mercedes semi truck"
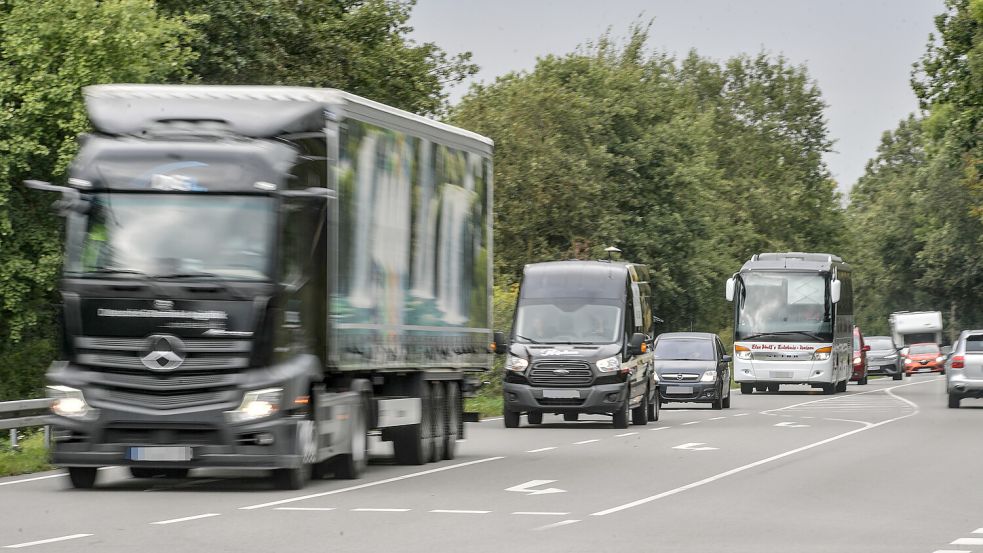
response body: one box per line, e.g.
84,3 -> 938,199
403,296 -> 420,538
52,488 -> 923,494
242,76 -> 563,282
66,193 -> 274,280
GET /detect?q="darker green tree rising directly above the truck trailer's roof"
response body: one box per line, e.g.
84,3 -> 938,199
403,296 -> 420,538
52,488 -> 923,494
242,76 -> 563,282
157,0 -> 477,114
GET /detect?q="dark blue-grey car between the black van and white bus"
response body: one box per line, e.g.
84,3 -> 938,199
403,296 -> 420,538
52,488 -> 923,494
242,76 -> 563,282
653,332 -> 731,409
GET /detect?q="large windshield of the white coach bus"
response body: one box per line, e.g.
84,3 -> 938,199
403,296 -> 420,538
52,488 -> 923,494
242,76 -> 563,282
734,272 -> 833,342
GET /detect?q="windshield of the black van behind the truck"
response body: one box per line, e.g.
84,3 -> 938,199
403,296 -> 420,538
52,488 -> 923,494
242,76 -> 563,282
515,299 -> 623,344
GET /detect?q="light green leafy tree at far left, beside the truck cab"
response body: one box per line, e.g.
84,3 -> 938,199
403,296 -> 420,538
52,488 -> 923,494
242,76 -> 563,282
0,0 -> 200,396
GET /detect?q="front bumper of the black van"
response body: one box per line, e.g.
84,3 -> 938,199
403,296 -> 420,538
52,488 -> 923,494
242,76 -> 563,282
503,382 -> 628,414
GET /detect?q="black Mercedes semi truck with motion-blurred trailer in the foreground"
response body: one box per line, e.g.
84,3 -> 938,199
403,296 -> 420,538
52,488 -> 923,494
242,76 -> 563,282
26,85 -> 494,489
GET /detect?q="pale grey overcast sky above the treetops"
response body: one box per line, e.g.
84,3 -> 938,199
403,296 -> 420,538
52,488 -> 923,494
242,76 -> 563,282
410,0 -> 944,198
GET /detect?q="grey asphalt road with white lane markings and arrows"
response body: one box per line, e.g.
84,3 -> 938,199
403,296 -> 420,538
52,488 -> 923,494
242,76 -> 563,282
0,375 -> 983,553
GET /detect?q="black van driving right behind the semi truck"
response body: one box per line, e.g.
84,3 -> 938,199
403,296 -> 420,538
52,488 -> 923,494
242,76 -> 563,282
503,261 -> 659,428
